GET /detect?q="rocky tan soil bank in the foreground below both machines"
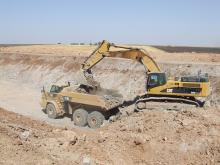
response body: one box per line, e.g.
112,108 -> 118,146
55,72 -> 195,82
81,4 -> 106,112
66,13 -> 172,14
0,109 -> 220,164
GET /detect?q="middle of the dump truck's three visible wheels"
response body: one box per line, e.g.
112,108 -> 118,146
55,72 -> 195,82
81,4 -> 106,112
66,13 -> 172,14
73,108 -> 88,127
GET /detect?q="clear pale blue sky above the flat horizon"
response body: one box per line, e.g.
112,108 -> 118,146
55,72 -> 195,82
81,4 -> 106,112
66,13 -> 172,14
0,0 -> 220,47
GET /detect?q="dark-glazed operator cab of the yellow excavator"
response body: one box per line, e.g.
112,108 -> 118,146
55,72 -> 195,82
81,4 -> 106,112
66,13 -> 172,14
147,73 -> 166,88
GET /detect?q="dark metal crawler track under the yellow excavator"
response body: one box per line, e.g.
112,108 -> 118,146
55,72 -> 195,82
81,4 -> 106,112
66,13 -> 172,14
135,97 -> 204,112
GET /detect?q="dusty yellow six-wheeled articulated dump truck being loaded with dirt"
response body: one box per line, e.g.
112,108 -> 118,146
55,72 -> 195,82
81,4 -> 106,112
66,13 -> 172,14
40,83 -> 123,128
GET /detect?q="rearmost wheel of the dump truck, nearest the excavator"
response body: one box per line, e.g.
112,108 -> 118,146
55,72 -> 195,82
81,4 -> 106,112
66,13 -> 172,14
88,111 -> 105,128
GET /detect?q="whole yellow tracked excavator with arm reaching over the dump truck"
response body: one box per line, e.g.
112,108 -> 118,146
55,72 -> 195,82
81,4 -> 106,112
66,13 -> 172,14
81,40 -> 210,111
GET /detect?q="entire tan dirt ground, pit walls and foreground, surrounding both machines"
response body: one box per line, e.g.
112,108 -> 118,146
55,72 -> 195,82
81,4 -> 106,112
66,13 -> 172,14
0,45 -> 220,164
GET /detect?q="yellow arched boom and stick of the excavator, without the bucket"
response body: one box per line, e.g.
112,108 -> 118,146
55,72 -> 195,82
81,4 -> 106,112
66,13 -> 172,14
82,40 -> 161,73
